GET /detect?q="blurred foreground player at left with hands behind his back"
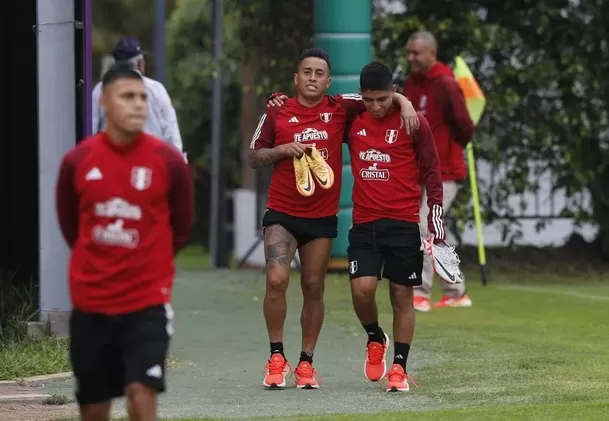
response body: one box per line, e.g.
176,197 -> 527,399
57,64 -> 193,421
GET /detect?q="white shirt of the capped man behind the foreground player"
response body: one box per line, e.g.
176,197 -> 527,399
93,76 -> 183,151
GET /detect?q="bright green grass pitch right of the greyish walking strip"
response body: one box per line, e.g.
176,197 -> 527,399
170,249 -> 609,421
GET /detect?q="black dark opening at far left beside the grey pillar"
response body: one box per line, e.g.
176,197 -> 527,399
0,0 -> 39,283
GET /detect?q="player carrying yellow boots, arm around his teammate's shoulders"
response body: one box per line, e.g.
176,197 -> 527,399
249,48 -> 418,389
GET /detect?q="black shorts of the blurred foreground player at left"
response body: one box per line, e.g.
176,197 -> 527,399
70,305 -> 173,405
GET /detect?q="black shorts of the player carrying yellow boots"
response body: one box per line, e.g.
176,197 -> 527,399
262,209 -> 338,247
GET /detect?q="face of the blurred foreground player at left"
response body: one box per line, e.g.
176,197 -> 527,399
101,78 -> 148,135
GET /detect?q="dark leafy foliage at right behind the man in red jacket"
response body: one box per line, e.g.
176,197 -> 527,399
375,0 -> 609,255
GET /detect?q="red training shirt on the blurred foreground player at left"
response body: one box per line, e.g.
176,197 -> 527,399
56,132 -> 194,315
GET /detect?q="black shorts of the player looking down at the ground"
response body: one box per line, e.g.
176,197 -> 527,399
347,219 -> 423,286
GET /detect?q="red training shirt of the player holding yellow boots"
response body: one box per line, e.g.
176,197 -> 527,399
250,94 -> 365,218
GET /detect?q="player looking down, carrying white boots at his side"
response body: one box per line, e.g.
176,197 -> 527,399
347,63 -> 445,391
